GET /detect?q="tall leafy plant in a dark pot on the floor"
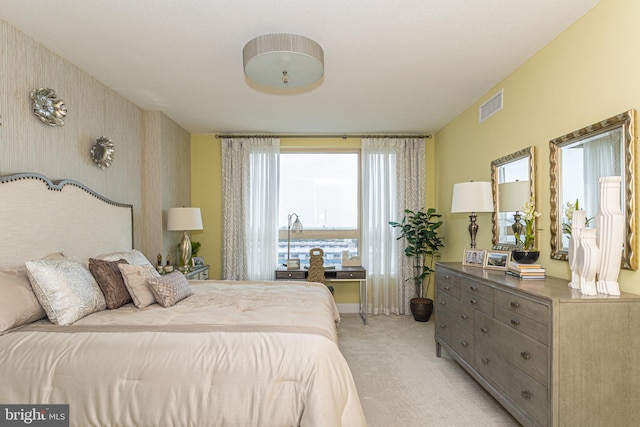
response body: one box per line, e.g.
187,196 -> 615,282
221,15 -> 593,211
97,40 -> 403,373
389,208 -> 444,322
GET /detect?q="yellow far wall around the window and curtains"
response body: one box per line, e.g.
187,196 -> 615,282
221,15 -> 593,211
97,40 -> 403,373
191,135 -> 435,303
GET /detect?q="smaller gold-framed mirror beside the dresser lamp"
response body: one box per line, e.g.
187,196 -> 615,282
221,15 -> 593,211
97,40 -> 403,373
491,147 -> 539,251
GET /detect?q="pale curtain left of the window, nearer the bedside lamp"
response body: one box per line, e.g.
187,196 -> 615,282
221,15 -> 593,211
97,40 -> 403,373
222,138 -> 280,280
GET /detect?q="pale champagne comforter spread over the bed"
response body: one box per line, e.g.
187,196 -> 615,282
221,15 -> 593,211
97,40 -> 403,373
0,281 -> 366,427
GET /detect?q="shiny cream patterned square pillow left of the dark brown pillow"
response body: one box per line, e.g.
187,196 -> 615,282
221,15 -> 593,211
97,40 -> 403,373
25,260 -> 106,325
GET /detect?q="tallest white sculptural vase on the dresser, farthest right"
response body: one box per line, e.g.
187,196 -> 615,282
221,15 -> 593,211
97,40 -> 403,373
596,176 -> 624,295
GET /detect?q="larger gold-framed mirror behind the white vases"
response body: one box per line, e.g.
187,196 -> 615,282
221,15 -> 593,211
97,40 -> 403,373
549,110 -> 638,270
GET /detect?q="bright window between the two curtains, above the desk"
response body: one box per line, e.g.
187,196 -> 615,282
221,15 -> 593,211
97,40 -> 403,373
278,151 -> 360,265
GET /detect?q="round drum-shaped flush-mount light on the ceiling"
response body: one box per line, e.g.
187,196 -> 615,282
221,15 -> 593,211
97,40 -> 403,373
242,34 -> 324,89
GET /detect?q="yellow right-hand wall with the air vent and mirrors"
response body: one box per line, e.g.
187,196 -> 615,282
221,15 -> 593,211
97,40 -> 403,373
435,0 -> 640,294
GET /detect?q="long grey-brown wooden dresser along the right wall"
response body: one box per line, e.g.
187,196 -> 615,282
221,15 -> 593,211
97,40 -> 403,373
434,263 -> 640,427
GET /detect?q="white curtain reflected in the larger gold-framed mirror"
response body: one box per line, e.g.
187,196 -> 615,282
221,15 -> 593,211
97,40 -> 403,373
580,129 -> 624,218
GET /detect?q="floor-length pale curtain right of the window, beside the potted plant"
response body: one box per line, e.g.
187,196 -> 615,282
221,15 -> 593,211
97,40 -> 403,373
360,138 -> 425,315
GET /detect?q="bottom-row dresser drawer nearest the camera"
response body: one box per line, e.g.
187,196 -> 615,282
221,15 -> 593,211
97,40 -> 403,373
475,341 -> 548,426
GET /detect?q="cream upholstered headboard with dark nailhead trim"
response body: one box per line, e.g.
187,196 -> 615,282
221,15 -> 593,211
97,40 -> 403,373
0,173 -> 133,267
